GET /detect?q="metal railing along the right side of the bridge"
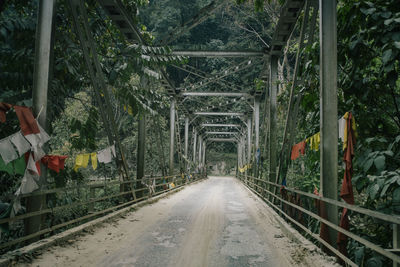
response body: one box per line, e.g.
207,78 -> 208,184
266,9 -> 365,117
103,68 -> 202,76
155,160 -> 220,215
237,175 -> 400,266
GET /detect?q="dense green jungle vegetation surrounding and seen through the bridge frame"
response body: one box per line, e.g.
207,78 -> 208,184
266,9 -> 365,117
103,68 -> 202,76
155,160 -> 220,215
0,0 -> 400,266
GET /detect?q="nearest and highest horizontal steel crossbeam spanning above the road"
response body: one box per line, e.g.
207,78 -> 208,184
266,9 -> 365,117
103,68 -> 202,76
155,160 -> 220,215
171,50 -> 265,58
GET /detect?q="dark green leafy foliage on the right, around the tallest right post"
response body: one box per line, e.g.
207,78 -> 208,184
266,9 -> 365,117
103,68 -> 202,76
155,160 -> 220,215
282,0 -> 400,266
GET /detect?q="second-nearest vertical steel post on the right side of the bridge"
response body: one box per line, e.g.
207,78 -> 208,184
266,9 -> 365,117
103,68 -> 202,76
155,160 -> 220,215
268,56 -> 278,196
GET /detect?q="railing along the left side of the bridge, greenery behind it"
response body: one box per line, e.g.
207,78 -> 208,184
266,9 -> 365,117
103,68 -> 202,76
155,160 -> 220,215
0,174 -> 206,255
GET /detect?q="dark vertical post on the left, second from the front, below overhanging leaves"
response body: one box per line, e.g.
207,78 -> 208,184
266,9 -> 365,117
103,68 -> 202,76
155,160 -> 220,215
136,113 -> 146,198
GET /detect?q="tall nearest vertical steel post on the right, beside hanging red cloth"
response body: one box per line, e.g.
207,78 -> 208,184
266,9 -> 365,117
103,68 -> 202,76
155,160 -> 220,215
319,0 -> 338,247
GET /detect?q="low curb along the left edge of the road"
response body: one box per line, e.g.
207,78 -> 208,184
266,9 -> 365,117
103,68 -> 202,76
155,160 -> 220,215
0,177 -> 208,267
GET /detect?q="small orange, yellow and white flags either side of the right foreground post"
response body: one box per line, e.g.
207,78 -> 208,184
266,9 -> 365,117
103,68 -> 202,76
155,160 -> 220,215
290,112 -> 357,160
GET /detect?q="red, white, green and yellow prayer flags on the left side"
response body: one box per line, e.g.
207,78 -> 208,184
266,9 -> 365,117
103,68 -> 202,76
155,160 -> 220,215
0,102 -> 116,214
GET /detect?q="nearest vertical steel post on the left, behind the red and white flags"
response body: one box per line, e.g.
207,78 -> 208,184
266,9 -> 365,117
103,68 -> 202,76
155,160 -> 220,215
24,0 -> 55,240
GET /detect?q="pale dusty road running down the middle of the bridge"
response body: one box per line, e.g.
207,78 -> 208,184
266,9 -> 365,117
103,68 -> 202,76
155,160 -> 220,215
25,177 -> 338,267
